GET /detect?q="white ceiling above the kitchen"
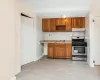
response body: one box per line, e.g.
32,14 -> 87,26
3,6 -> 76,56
24,0 -> 92,17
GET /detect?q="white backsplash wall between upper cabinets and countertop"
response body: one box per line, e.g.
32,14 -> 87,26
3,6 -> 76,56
44,32 -> 85,40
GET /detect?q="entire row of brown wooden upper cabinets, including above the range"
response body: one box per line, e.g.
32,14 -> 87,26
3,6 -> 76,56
42,17 -> 85,32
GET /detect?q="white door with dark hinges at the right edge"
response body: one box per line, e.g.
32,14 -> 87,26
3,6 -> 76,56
94,17 -> 100,65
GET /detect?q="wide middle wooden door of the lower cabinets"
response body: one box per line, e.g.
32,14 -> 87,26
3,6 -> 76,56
54,44 -> 66,58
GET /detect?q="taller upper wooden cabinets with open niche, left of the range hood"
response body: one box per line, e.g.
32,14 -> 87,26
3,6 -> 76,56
42,18 -> 72,32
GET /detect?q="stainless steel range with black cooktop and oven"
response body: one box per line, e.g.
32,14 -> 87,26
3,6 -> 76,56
72,37 -> 87,60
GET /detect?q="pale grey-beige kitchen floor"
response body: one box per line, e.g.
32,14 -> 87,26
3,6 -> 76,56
17,57 -> 100,80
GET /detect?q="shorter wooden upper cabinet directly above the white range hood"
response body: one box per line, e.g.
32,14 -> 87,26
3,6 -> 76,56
72,17 -> 85,28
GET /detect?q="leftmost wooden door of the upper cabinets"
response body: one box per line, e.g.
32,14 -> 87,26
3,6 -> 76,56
42,19 -> 50,32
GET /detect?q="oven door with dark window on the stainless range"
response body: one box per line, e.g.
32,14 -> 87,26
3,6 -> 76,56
72,46 -> 85,55
